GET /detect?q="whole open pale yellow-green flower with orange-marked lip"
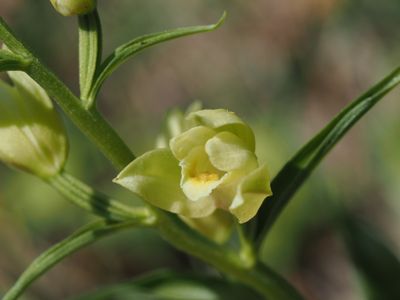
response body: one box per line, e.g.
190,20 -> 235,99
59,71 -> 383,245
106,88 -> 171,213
114,109 -> 272,227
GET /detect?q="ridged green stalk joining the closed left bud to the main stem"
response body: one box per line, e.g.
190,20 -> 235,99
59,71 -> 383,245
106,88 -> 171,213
46,172 -> 155,225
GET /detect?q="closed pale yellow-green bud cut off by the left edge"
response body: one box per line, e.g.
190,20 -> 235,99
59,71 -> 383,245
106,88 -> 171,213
0,72 -> 68,178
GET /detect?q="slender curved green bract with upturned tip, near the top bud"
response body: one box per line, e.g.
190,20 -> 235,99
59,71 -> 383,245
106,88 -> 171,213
90,13 -> 226,101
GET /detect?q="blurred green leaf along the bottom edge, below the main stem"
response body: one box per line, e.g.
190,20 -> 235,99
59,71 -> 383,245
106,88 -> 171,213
74,271 -> 263,300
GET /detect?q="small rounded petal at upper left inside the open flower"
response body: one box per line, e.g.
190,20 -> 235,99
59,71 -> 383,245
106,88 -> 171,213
169,126 -> 216,160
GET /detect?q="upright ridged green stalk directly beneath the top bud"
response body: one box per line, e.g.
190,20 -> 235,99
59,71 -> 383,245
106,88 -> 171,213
79,10 -> 102,107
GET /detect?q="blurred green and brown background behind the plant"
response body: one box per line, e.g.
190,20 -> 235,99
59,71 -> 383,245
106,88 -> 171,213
0,0 -> 400,300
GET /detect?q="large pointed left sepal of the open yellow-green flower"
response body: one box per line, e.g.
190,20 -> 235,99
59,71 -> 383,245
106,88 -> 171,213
114,149 -> 215,218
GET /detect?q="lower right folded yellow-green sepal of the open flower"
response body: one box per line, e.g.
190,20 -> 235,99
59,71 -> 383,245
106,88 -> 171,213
229,165 -> 272,223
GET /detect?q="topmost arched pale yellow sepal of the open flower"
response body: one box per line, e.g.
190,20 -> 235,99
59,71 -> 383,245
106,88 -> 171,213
187,109 -> 255,152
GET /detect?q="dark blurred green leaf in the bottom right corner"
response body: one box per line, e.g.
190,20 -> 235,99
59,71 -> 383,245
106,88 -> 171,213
343,218 -> 400,300
